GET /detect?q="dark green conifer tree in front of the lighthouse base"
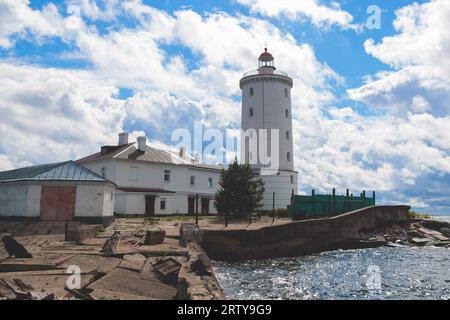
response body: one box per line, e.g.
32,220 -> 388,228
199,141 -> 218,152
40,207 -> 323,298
214,159 -> 264,222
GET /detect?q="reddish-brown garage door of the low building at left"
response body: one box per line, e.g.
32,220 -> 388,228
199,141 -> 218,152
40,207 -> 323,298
41,186 -> 76,221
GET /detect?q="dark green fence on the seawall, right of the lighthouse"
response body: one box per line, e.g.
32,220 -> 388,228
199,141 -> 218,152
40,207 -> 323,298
287,190 -> 375,219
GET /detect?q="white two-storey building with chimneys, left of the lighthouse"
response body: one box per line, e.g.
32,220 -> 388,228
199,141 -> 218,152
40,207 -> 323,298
78,133 -> 222,216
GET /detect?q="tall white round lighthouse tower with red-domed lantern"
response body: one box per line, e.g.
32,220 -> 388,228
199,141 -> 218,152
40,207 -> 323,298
239,48 -> 298,210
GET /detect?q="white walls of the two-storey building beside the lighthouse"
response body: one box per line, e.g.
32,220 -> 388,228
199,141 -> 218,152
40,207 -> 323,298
83,159 -> 220,215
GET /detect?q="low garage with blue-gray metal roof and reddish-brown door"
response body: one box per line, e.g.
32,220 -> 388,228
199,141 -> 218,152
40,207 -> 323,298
0,161 -> 116,224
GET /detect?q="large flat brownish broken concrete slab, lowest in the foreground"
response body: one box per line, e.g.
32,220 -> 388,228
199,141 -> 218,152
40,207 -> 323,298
88,268 -> 177,300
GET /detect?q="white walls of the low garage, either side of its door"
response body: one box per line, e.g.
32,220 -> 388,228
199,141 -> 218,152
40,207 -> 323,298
0,181 -> 115,218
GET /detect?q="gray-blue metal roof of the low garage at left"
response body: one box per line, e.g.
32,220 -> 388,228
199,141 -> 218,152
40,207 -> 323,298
0,161 -> 110,182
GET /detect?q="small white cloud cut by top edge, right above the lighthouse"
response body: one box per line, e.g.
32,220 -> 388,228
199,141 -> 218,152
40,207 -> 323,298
237,0 -> 356,29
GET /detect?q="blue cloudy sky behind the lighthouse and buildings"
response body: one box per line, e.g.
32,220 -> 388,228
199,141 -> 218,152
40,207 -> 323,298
0,0 -> 450,215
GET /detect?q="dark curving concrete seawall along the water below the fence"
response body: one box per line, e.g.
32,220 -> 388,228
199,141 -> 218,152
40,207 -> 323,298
201,205 -> 410,261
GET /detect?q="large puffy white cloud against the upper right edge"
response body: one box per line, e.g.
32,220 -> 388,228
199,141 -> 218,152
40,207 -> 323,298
348,0 -> 450,116
